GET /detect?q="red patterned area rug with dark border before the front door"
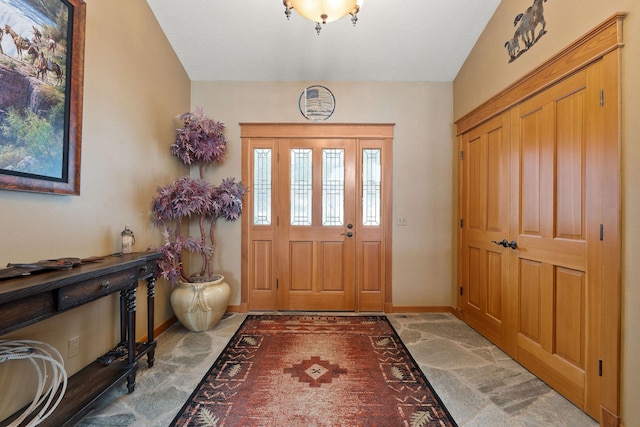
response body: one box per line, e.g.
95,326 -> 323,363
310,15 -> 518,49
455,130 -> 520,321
171,315 -> 456,427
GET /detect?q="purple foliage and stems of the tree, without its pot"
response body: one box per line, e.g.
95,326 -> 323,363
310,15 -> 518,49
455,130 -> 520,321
152,108 -> 247,285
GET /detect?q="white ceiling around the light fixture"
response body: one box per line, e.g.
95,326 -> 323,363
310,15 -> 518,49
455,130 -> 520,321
147,0 -> 500,82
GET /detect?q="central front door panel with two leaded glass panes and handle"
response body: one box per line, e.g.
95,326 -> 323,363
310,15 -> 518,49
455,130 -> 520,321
278,139 -> 359,311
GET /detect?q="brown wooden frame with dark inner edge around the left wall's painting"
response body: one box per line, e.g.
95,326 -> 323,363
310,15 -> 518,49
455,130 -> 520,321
0,0 -> 86,195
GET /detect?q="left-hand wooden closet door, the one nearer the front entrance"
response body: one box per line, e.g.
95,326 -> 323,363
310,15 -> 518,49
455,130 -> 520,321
459,113 -> 510,346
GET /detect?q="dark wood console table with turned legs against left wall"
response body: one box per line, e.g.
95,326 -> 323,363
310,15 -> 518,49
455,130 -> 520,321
0,252 -> 161,427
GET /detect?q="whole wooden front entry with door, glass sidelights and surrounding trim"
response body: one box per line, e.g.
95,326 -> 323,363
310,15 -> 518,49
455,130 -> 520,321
242,124 -> 393,311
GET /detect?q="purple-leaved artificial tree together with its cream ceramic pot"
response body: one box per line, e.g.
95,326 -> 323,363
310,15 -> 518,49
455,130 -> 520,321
152,108 -> 247,331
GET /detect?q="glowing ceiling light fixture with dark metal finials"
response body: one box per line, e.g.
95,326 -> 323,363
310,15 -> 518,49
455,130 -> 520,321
282,0 -> 363,35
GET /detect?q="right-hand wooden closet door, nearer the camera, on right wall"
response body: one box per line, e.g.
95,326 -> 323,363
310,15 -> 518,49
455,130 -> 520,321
509,65 -> 601,418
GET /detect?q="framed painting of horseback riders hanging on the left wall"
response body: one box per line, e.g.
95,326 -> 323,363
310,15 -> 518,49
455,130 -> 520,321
0,0 -> 86,195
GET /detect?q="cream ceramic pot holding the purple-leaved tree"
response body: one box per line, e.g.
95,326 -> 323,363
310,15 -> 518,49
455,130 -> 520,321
171,274 -> 231,332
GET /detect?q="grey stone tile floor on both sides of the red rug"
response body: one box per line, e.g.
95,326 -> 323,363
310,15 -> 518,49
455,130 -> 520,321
77,313 -> 598,427
